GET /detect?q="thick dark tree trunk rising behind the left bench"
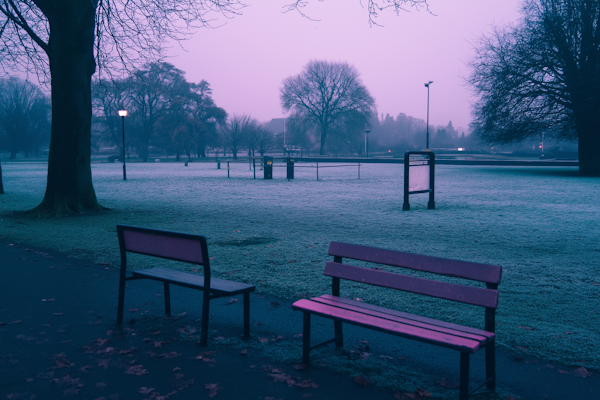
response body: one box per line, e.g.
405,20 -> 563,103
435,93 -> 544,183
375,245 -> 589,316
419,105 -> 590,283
30,0 -> 103,218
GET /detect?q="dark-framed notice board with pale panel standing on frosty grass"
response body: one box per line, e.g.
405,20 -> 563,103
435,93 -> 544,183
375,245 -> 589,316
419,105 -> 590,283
402,151 -> 435,211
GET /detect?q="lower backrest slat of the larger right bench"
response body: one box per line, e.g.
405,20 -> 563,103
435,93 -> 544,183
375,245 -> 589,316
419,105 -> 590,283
324,261 -> 498,308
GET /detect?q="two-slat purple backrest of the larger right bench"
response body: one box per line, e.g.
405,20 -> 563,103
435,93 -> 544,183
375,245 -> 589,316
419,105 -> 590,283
325,242 -> 502,310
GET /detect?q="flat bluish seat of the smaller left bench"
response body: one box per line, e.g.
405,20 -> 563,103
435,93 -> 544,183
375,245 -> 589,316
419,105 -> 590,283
132,267 -> 256,295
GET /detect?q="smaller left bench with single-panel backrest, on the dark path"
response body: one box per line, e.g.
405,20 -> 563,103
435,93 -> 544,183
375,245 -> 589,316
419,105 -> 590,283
117,225 -> 255,346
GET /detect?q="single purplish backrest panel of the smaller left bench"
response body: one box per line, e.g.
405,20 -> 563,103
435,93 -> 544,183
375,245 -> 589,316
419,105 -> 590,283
123,227 -> 204,264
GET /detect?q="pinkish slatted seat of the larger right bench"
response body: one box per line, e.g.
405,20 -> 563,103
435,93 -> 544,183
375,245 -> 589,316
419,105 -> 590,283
292,295 -> 495,353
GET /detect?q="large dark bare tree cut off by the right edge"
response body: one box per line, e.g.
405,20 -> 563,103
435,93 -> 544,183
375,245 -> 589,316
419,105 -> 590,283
468,0 -> 600,176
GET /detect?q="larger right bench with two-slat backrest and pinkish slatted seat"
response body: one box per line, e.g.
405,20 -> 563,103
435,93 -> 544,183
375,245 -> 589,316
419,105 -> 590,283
292,242 -> 502,400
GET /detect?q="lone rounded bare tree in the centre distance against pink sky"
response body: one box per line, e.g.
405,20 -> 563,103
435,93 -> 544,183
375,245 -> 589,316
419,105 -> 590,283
280,60 -> 375,154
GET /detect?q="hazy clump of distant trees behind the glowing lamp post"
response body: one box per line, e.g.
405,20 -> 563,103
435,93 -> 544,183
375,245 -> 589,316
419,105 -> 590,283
92,62 -> 273,162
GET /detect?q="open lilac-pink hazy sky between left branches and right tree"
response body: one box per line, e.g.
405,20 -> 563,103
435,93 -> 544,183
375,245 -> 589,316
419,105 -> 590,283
167,0 -> 521,134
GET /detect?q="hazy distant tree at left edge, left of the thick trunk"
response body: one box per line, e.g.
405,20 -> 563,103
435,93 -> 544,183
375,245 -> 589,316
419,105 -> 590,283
0,78 -> 50,159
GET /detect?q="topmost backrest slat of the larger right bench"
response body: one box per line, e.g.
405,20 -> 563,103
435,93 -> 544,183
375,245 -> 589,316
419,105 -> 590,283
329,242 -> 502,284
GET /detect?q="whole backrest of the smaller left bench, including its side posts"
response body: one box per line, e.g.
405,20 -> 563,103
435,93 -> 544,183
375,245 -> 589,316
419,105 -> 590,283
117,225 -> 210,278
